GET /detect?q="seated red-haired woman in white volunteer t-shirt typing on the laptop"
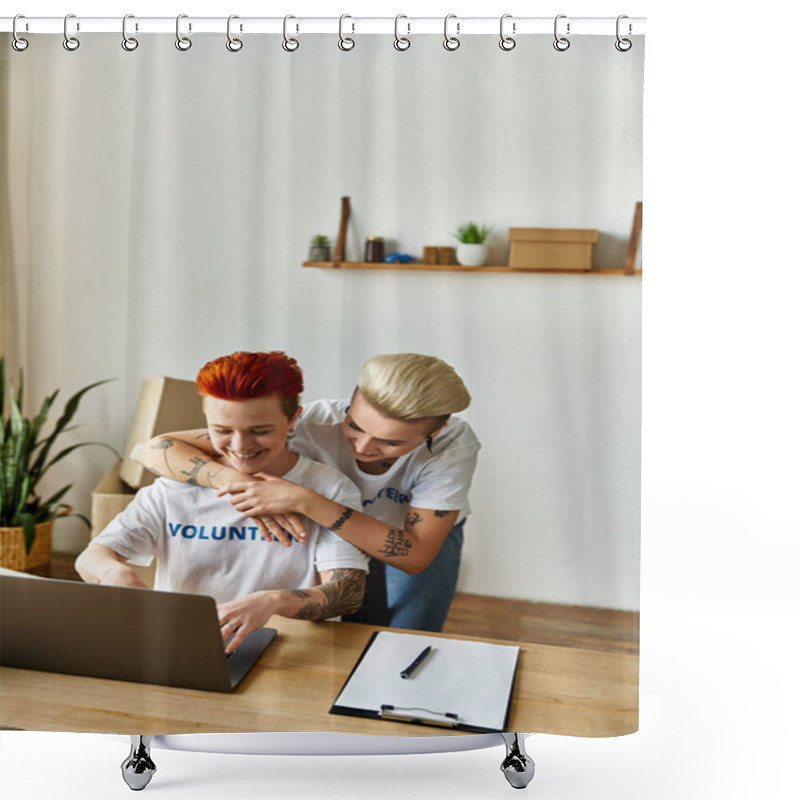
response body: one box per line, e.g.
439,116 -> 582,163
75,353 -> 367,652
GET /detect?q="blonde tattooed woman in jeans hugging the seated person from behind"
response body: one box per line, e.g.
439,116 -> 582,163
133,353 -> 480,631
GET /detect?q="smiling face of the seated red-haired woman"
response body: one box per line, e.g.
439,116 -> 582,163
203,394 -> 300,475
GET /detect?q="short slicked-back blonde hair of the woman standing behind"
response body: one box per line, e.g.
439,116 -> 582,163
358,353 -> 471,420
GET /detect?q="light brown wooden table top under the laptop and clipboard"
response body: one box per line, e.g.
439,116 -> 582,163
0,617 -> 639,736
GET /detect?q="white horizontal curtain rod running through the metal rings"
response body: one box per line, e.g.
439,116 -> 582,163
0,14 -> 645,36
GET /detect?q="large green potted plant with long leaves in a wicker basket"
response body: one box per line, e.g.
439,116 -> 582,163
0,358 -> 116,572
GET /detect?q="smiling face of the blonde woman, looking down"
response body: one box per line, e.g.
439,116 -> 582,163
342,391 -> 444,464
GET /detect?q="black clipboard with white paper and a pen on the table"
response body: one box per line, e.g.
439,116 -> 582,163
329,631 -> 519,733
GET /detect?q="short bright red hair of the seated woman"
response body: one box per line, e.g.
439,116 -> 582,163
196,350 -> 303,419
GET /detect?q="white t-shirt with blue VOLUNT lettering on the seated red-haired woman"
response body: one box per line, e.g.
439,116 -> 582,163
93,456 -> 368,603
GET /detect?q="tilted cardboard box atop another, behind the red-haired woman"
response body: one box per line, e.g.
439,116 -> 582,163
119,378 -> 206,489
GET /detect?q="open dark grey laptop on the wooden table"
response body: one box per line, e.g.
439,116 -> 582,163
0,574 -> 277,692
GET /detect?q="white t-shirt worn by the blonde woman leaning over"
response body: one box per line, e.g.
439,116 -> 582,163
289,400 -> 481,528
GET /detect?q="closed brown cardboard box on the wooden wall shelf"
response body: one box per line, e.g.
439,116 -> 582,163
508,228 -> 597,270
